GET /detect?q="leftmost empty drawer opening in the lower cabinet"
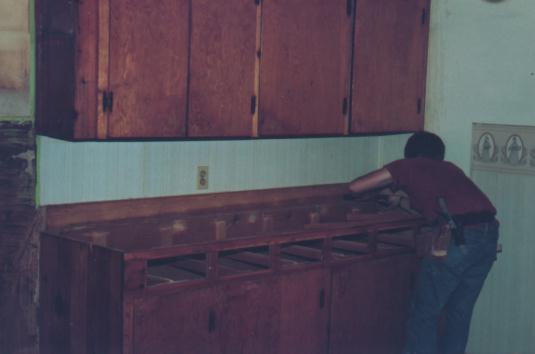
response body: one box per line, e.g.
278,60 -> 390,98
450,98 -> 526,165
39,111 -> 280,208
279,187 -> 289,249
147,254 -> 207,286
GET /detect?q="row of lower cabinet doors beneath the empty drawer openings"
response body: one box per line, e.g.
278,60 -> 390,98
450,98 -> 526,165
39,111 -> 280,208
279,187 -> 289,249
130,254 -> 415,354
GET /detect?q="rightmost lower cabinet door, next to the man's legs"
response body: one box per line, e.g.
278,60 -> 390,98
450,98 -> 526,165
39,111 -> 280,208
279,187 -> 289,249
329,254 -> 416,354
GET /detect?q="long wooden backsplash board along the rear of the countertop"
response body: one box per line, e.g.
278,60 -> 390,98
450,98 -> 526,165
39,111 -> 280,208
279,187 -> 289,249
46,183 -> 348,229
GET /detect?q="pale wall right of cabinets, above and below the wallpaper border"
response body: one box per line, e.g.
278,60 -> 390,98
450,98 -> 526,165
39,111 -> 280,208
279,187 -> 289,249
426,0 -> 535,354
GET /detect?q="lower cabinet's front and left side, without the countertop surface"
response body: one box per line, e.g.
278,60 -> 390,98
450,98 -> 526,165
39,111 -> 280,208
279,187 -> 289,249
40,226 -> 416,354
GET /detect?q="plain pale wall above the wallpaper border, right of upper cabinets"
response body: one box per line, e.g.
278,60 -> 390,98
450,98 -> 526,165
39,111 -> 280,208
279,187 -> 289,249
426,0 -> 535,172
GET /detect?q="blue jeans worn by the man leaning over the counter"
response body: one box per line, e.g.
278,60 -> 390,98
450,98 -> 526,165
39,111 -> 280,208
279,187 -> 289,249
405,221 -> 499,354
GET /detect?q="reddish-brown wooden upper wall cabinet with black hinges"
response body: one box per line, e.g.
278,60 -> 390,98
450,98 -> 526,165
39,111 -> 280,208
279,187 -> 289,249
36,0 -> 430,141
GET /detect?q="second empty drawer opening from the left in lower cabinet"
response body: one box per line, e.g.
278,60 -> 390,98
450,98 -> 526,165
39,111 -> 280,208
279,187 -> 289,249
217,246 -> 271,277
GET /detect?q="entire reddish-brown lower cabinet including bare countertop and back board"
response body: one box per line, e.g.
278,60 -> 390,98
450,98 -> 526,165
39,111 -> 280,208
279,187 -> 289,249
40,186 -> 421,354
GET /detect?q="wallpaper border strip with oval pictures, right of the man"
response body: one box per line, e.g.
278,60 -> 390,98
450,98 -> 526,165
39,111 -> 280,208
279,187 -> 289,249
472,123 -> 535,175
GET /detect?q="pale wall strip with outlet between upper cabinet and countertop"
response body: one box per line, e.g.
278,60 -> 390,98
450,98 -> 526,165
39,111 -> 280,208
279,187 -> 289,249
38,137 -> 380,205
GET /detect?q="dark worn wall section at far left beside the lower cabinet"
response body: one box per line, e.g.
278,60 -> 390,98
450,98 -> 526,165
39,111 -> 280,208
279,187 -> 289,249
0,121 -> 39,354
